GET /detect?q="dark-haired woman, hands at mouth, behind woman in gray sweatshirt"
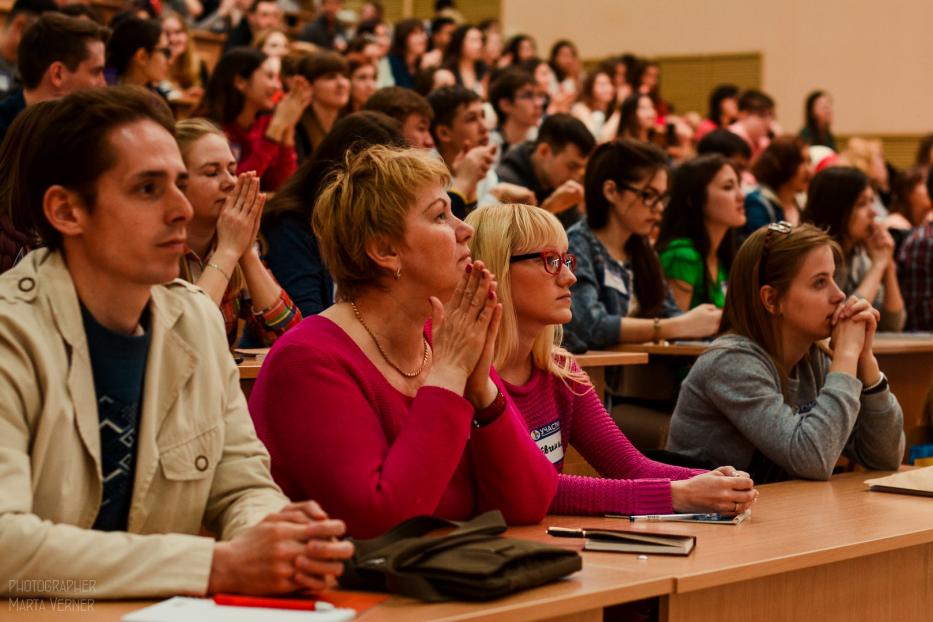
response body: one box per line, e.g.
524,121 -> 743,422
805,166 -> 904,331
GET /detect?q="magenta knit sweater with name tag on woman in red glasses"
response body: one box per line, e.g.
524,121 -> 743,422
505,369 -> 704,514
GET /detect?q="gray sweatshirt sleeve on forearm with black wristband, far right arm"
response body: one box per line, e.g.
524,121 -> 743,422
845,389 -> 906,471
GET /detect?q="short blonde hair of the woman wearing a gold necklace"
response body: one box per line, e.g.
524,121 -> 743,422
311,145 -> 450,300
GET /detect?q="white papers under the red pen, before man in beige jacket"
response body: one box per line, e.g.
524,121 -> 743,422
123,596 -> 356,622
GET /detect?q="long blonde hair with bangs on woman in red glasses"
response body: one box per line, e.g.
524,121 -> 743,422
466,204 -> 591,386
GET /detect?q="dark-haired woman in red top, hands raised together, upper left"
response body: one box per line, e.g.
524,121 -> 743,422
194,47 -> 311,191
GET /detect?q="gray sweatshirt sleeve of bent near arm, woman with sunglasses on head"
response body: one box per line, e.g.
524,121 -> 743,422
691,350 -> 862,480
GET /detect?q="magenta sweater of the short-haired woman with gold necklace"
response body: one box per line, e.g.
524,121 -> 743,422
249,316 -> 557,538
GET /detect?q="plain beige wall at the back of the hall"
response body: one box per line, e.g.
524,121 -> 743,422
502,0 -> 933,134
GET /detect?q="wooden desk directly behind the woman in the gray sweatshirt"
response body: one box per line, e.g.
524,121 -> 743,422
612,333 -> 933,448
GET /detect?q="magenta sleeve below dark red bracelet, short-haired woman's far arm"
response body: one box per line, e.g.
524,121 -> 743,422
470,370 -> 558,525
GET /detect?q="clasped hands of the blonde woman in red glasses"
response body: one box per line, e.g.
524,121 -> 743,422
671,466 -> 758,514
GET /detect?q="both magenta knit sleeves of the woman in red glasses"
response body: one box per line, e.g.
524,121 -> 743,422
551,382 -> 704,514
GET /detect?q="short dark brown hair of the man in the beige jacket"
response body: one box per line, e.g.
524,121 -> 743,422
7,86 -> 175,250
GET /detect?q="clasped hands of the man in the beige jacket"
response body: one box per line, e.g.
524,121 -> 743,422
207,501 -> 353,594
